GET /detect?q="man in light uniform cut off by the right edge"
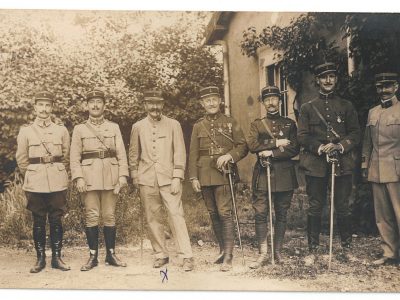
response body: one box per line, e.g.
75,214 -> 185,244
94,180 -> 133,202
361,73 -> 400,265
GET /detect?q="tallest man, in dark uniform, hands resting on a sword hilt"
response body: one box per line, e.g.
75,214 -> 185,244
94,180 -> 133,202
297,63 -> 360,257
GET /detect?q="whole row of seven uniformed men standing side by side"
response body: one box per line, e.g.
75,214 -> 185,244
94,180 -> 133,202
16,63 -> 400,273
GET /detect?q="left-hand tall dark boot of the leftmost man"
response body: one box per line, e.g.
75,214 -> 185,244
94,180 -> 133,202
29,216 -> 46,273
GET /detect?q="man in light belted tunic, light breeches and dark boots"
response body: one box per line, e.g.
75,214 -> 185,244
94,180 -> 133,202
71,89 -> 129,271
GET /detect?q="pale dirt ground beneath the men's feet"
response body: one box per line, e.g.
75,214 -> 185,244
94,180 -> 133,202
0,233 -> 400,292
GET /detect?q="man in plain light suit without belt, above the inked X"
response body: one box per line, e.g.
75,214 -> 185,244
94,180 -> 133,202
129,89 -> 194,271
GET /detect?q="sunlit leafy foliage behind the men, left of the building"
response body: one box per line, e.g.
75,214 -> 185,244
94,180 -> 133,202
0,11 -> 222,184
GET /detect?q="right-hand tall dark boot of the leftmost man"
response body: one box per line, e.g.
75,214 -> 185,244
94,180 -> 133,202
50,220 -> 71,271
